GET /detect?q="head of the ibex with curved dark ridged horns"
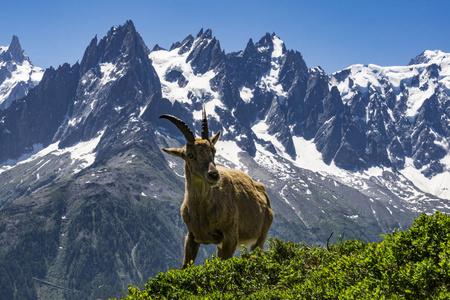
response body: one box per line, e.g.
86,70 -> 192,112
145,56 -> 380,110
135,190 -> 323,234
160,107 -> 220,186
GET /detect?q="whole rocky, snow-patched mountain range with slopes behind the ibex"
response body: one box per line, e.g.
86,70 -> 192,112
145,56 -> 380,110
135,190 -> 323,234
0,21 -> 450,299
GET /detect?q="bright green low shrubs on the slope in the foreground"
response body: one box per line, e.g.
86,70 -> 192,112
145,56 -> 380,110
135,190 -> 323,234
122,212 -> 450,299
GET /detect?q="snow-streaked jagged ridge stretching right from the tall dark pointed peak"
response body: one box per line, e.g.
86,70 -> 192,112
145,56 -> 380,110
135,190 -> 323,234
150,31 -> 450,199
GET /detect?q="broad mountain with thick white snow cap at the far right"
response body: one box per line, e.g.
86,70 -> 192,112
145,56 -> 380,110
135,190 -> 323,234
330,51 -> 450,199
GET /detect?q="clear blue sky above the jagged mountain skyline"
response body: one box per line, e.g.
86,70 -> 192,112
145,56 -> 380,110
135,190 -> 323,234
0,0 -> 450,74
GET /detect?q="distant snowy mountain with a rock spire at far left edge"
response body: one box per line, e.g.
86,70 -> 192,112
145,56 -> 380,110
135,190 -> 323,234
0,35 -> 44,109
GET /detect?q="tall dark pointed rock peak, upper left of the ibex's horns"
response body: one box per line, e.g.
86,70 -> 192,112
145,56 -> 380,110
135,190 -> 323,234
55,21 -> 161,148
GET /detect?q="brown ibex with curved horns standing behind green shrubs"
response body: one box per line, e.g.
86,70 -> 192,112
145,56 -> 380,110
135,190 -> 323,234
160,107 -> 273,269
